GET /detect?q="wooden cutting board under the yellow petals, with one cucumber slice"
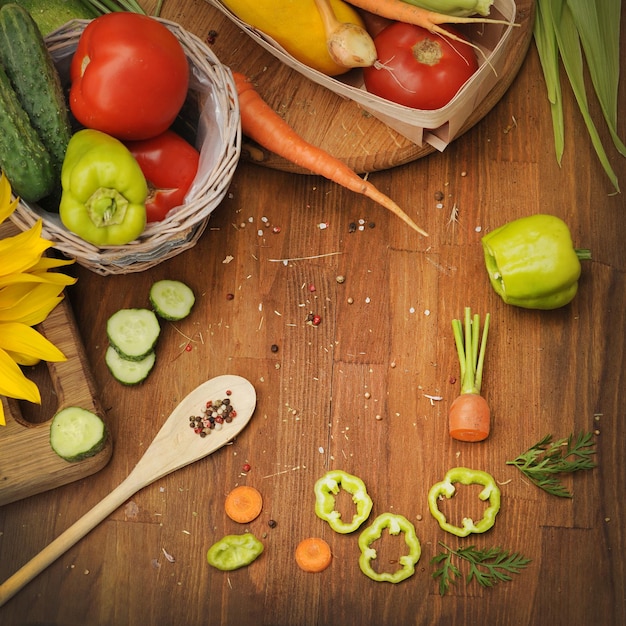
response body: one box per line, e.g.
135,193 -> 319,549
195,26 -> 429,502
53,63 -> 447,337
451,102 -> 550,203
0,224 -> 113,506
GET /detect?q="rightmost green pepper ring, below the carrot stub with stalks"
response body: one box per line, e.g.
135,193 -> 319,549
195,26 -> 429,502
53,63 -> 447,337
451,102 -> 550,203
428,467 -> 500,537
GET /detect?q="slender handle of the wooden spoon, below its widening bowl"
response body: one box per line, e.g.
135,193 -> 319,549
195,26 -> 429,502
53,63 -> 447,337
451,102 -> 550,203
0,479 -> 138,606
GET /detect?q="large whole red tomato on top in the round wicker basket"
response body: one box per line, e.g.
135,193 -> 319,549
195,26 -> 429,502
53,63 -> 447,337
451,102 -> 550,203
70,12 -> 189,140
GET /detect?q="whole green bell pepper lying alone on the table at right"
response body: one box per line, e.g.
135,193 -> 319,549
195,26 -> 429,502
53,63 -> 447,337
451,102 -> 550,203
482,214 -> 591,309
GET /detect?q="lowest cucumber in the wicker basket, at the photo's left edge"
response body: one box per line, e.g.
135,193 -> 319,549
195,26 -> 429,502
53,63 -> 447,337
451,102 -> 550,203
0,65 -> 58,202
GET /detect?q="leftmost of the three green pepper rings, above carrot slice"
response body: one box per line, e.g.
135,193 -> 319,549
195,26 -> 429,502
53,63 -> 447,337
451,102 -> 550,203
314,470 -> 373,534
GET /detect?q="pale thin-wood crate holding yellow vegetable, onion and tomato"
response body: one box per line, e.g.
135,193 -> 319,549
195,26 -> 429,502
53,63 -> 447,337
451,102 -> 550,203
206,0 -> 516,150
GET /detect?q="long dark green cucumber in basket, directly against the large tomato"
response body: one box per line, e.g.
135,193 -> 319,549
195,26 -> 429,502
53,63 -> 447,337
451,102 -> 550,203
0,4 -> 72,178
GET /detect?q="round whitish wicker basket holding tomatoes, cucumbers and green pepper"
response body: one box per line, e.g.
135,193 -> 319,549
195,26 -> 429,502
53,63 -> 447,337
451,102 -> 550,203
11,19 -> 241,275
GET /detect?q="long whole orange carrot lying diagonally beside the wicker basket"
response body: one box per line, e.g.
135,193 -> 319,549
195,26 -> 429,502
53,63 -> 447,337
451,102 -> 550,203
233,72 -> 428,237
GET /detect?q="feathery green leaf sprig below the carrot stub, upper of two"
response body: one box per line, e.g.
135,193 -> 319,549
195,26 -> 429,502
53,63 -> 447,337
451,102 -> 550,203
506,432 -> 596,498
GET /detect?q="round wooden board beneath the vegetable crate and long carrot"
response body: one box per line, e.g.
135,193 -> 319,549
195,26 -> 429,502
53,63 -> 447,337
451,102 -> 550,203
193,0 -> 535,173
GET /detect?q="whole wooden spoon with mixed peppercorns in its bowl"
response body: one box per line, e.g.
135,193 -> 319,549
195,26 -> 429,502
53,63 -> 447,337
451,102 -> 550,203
0,375 -> 256,606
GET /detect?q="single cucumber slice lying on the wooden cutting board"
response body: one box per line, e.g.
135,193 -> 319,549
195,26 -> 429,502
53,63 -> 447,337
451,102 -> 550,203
50,406 -> 108,463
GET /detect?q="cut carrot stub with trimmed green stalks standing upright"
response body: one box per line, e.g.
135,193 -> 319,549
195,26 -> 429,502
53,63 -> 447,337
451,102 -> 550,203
448,307 -> 491,441
